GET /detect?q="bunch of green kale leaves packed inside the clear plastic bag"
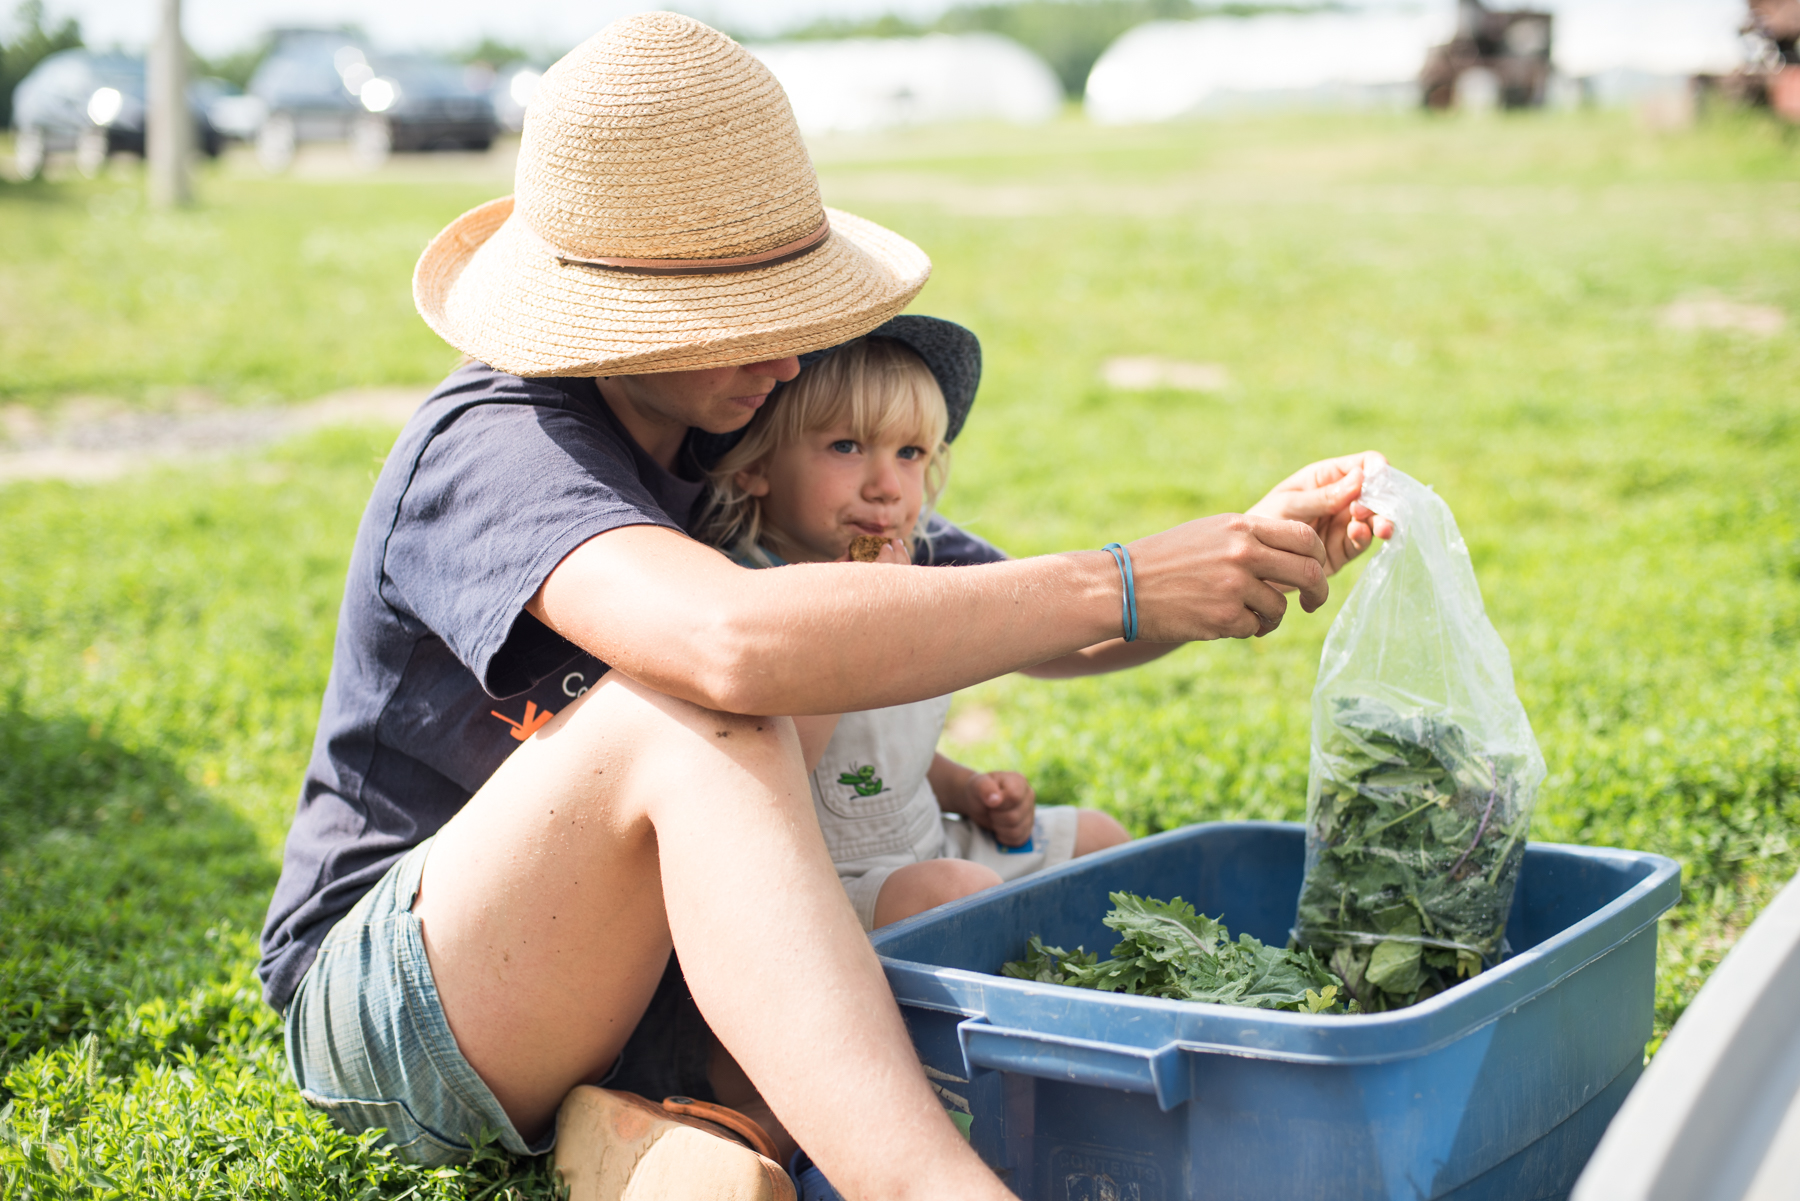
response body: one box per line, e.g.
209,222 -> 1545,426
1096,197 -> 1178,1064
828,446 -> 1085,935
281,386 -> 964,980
1294,695 -> 1532,1014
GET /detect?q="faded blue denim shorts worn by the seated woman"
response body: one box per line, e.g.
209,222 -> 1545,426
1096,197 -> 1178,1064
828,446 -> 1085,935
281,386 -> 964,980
286,839 -> 713,1167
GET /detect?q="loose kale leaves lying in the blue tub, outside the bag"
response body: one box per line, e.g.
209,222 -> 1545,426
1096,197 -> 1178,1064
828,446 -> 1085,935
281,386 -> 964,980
1001,893 -> 1345,1014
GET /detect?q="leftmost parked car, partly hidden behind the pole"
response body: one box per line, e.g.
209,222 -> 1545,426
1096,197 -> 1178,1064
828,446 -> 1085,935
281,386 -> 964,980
13,50 -> 234,180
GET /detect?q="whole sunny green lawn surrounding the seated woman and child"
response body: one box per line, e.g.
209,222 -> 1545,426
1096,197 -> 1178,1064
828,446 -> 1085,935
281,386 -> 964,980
0,113 -> 1800,1197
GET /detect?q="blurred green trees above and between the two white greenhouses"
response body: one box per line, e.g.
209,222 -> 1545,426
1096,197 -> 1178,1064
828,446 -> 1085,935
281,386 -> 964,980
766,0 -> 1337,99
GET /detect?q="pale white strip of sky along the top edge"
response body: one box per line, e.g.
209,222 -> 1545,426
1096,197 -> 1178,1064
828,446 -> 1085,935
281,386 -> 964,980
21,0 -> 1744,58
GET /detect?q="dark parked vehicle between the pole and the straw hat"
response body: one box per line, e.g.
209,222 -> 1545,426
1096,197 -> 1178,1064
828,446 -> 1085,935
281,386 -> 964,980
250,29 -> 497,171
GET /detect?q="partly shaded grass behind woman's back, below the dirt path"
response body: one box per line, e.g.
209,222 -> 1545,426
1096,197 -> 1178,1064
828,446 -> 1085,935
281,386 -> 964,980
0,430 -> 561,1197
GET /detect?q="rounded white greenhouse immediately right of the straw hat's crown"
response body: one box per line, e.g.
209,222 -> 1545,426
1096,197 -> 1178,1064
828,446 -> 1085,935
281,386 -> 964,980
751,32 -> 1062,133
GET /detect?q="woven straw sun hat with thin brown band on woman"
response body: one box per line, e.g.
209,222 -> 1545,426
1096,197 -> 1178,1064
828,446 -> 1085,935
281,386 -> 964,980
412,13 -> 931,375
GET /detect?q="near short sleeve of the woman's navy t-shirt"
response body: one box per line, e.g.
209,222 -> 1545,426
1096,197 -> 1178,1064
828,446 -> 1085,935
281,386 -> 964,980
382,403 -> 680,697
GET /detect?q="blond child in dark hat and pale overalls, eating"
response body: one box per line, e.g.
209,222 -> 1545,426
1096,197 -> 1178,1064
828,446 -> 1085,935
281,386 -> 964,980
704,317 -> 1130,929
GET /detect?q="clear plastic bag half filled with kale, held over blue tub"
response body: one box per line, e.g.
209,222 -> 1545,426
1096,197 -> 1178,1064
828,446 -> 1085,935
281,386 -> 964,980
1292,468 -> 1544,1012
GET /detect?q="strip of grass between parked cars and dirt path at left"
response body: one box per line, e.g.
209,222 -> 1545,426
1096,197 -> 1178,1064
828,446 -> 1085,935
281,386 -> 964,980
0,167 -> 486,405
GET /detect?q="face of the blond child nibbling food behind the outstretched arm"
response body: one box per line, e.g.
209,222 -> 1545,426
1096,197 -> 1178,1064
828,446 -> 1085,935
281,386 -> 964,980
738,425 -> 931,564
